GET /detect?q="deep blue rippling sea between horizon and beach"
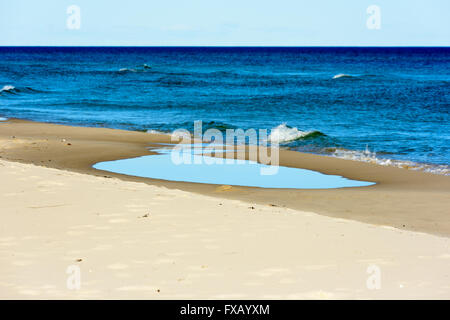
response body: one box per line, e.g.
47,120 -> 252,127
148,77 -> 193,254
0,47 -> 450,169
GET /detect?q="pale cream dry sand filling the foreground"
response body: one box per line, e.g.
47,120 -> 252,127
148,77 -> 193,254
0,161 -> 450,299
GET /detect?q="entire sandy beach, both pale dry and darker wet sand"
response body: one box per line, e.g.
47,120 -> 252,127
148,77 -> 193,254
0,119 -> 450,299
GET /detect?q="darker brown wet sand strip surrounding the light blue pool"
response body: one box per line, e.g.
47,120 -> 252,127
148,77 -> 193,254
0,118 -> 450,237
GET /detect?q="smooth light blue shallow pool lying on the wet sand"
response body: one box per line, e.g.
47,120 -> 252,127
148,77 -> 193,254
93,145 -> 374,189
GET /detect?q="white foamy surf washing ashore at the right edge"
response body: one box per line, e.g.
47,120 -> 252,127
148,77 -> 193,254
327,148 -> 450,175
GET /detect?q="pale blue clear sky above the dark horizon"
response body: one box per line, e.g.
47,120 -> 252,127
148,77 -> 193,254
0,0 -> 450,46
